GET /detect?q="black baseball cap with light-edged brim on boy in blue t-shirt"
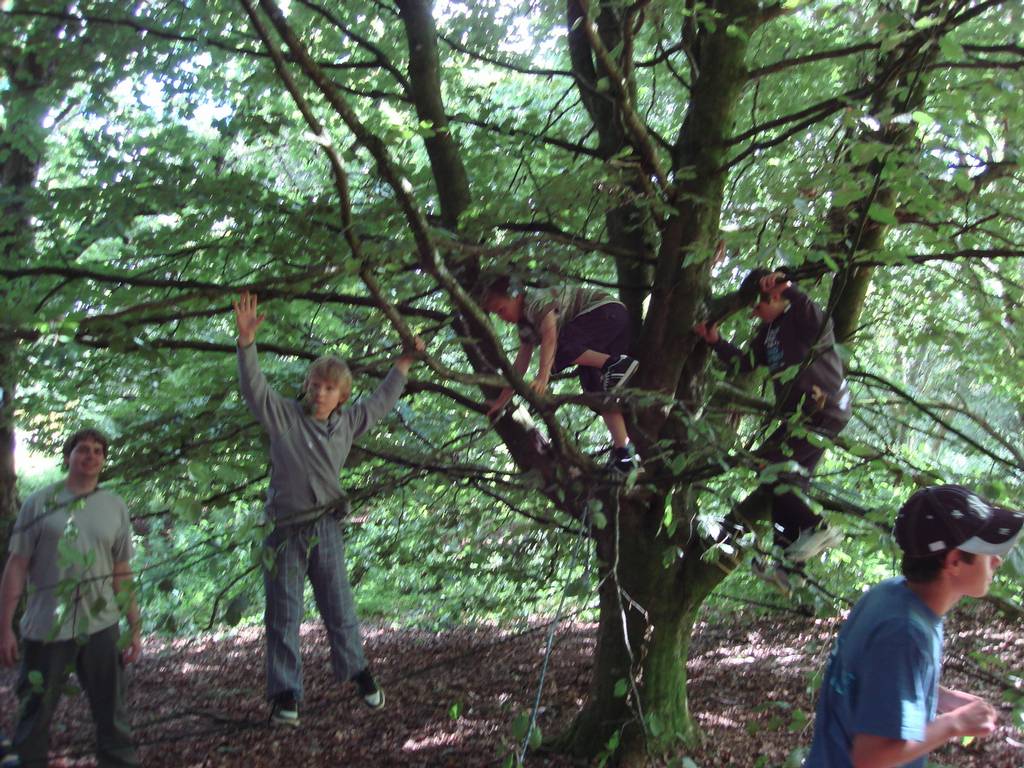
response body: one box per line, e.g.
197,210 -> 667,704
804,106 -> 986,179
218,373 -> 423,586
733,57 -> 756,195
893,485 -> 1024,557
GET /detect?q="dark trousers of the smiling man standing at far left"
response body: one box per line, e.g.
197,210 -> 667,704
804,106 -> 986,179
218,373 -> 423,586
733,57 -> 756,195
11,625 -> 139,768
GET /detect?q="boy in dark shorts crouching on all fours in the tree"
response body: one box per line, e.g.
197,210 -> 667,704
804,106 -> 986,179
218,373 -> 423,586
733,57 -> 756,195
480,275 -> 638,474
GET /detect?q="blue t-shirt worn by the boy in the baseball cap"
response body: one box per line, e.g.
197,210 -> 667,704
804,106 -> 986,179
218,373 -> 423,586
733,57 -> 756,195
804,577 -> 942,768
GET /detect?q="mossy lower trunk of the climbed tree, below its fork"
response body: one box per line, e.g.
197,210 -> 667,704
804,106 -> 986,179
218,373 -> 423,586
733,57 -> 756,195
557,487 -> 753,765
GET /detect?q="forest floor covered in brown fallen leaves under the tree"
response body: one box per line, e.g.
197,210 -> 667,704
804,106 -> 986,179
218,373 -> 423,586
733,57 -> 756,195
0,608 -> 1024,768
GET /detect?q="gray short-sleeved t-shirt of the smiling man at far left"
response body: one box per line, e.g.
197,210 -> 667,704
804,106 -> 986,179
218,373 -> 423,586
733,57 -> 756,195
9,480 -> 132,642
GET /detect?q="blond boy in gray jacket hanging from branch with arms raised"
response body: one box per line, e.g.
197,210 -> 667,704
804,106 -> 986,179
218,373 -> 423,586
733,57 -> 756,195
233,291 -> 424,725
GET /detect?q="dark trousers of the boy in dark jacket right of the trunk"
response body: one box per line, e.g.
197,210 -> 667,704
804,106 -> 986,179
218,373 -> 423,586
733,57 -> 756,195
757,412 -> 850,549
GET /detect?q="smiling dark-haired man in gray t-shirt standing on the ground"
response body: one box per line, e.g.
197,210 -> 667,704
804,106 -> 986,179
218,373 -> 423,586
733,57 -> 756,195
0,429 -> 141,766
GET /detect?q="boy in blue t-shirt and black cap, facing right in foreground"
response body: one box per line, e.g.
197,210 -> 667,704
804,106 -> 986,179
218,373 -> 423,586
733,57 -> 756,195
804,485 -> 1024,768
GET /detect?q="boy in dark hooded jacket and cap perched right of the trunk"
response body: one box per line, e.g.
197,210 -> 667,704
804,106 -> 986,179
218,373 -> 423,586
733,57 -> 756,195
694,269 -> 851,590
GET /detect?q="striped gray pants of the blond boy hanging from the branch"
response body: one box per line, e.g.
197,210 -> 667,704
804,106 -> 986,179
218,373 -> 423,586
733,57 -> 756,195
263,515 -> 367,700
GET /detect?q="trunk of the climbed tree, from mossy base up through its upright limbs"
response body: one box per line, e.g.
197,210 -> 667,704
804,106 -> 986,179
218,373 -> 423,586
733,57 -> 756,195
559,0 -> 757,765
